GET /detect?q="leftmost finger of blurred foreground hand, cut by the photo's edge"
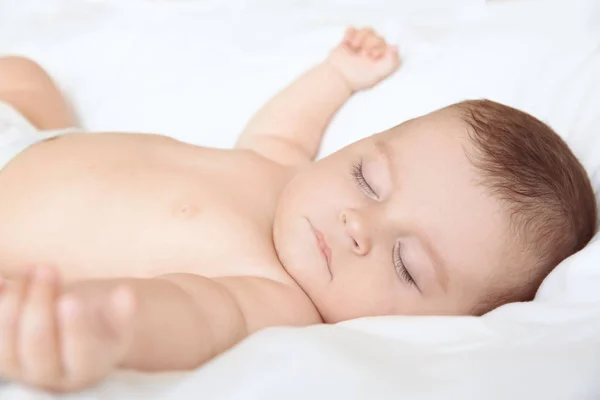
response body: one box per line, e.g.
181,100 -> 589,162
0,275 -> 28,380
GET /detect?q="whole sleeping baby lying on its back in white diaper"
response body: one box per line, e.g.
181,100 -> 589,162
0,28 -> 596,391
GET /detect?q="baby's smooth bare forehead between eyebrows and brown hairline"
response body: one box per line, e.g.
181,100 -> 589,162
375,110 -> 508,296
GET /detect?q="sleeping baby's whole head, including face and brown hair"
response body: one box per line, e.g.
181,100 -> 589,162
274,100 -> 596,322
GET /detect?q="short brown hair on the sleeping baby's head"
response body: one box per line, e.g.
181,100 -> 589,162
453,100 -> 597,314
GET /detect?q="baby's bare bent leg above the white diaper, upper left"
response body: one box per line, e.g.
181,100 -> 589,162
0,57 -> 77,130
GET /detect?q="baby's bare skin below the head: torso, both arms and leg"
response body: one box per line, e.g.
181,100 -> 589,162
0,28 -> 408,391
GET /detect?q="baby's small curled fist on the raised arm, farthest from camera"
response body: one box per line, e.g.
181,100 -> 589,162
327,27 -> 400,91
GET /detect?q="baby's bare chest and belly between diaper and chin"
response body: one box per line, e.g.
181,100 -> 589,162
0,134 -> 286,280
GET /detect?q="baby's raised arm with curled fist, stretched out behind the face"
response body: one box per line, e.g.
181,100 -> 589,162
237,28 -> 399,165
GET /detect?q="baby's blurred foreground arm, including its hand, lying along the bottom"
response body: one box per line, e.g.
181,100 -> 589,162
0,268 -> 320,391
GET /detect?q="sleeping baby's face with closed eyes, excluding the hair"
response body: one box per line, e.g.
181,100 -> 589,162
274,110 -> 509,322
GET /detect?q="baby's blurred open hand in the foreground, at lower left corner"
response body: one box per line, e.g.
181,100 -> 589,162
0,268 -> 136,392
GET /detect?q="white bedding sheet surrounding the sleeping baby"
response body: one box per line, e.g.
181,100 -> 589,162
0,0 -> 600,400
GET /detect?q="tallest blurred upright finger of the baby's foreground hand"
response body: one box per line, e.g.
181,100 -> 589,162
19,267 -> 62,385
